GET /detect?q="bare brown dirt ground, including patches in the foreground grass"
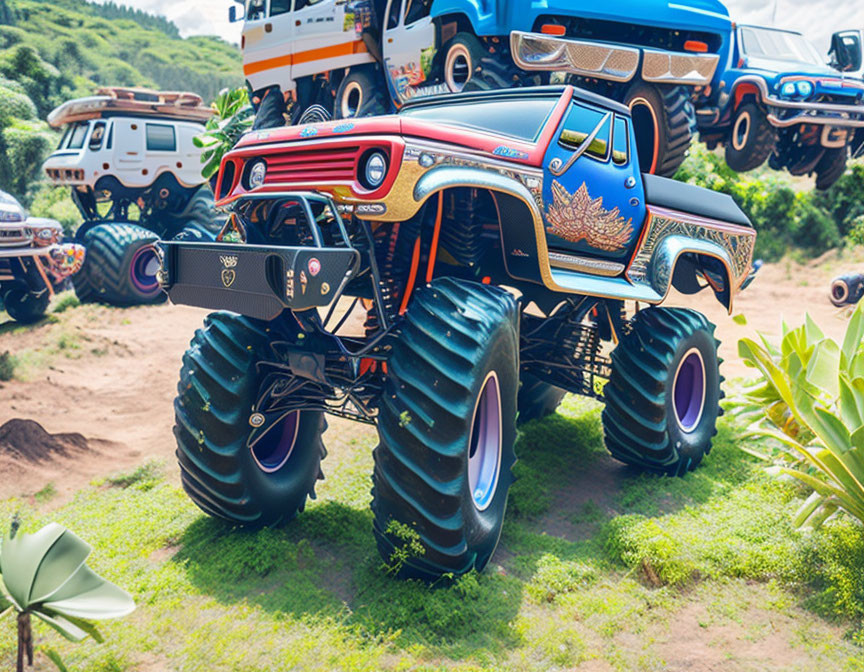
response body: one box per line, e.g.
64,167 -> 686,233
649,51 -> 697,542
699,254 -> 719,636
0,251 -> 864,671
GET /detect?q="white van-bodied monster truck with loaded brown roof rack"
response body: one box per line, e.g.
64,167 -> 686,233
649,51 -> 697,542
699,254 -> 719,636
44,88 -> 224,306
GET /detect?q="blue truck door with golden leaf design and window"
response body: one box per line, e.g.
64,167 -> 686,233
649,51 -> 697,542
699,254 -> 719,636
543,101 -> 645,260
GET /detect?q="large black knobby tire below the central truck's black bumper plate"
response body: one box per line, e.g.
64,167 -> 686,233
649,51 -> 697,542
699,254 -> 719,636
174,313 -> 326,527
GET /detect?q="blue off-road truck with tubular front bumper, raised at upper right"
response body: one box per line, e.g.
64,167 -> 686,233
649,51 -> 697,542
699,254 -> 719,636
696,26 -> 864,189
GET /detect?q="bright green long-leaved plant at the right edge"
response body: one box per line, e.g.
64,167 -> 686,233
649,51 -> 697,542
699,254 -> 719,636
734,305 -> 864,527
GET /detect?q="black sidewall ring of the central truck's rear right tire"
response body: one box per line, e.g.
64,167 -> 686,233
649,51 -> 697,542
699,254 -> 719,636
666,329 -> 720,462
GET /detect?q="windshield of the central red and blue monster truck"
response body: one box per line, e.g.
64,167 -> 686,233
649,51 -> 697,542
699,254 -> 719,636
400,96 -> 558,142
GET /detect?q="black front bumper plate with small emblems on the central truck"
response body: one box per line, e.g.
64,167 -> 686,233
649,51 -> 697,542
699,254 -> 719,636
160,242 -> 360,320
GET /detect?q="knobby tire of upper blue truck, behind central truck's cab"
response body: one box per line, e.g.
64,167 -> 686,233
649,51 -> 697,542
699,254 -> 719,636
624,82 -> 695,177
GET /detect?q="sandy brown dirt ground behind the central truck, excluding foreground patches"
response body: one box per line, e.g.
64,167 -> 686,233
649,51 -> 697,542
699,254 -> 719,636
0,255 -> 864,502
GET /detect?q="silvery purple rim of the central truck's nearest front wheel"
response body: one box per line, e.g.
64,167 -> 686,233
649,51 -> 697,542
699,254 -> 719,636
468,372 -> 501,511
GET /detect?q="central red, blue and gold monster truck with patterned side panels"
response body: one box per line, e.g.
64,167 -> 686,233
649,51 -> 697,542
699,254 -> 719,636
160,86 -> 756,580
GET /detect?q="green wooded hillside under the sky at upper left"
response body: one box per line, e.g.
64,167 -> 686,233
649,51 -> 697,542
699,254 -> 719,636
0,0 -> 242,108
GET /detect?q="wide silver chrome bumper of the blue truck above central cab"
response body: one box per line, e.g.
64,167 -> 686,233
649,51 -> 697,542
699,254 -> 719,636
510,30 -> 720,86
